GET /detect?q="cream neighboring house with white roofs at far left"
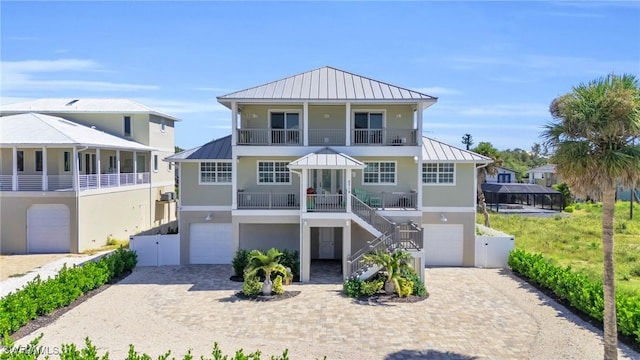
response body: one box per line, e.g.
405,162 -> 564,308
0,99 -> 179,254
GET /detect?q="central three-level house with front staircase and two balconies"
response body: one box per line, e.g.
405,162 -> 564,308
166,67 -> 491,281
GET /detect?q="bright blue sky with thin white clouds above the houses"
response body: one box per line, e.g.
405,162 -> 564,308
0,1 -> 640,150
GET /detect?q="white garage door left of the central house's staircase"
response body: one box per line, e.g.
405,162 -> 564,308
189,224 -> 233,264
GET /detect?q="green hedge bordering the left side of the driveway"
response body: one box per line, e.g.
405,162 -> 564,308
0,248 -> 138,335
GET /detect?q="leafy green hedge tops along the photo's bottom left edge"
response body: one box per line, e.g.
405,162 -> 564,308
0,334 -> 292,360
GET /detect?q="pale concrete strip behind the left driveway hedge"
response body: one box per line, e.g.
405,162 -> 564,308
0,250 -> 114,299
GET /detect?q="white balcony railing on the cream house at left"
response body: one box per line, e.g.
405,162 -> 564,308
0,172 -> 151,191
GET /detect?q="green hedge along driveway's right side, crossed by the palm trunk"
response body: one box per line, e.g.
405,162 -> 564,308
509,250 -> 640,343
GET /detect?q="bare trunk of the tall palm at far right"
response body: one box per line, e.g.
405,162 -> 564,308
602,187 -> 618,360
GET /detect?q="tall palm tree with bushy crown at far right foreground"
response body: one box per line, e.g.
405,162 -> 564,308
543,75 -> 640,359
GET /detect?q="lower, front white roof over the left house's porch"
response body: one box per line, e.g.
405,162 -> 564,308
0,113 -> 154,151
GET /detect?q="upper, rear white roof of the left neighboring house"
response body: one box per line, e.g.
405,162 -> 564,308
0,98 -> 180,121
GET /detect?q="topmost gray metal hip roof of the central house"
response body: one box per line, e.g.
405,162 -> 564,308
218,66 -> 438,106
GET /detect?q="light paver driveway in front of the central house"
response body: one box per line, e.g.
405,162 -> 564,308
19,265 -> 640,359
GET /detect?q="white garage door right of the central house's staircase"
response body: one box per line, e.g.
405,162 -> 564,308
424,224 -> 464,266
